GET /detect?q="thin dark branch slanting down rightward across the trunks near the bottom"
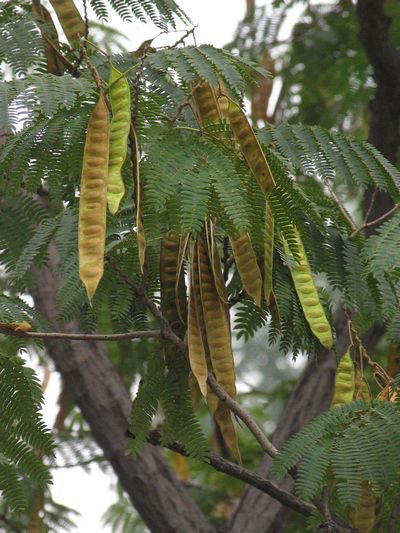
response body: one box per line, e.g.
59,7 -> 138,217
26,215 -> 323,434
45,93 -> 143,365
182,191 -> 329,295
148,430 -> 315,516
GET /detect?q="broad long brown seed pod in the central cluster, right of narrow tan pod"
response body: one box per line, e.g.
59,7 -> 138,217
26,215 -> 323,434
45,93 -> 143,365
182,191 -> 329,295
197,237 -> 236,398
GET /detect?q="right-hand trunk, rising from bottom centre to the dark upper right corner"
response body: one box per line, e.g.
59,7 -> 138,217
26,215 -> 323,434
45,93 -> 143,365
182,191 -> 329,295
229,0 -> 400,533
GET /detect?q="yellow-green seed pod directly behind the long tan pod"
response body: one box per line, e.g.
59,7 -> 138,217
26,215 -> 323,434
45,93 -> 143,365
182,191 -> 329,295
107,63 -> 131,214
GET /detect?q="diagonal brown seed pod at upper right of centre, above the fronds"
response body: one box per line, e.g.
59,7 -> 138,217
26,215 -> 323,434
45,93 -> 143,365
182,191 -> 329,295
228,99 -> 275,196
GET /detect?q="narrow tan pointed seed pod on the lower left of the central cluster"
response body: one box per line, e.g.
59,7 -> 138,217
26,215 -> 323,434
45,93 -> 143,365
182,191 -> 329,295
188,282 -> 208,396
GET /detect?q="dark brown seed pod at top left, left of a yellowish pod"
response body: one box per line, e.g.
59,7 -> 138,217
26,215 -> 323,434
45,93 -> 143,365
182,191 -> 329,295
32,0 -> 64,76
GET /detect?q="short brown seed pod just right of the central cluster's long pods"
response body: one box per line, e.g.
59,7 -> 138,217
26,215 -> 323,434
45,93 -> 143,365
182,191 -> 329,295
230,233 -> 262,306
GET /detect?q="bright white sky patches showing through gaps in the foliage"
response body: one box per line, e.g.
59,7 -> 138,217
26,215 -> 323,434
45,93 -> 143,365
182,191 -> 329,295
38,0 -> 304,533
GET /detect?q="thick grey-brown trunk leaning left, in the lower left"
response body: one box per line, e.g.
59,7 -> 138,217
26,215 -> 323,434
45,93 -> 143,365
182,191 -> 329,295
32,246 -> 214,533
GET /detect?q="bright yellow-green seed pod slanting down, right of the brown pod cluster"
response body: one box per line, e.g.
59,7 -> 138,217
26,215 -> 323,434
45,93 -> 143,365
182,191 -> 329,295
283,230 -> 333,348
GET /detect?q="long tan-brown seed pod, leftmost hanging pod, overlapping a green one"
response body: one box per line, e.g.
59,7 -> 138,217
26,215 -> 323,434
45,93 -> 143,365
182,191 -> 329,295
79,93 -> 109,301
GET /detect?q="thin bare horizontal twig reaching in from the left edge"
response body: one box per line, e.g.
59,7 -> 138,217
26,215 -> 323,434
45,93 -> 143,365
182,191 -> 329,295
0,326 -> 161,341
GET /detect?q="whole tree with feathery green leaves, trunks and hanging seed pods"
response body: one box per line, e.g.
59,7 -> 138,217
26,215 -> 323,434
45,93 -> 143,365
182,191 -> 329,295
0,0 -> 400,532
